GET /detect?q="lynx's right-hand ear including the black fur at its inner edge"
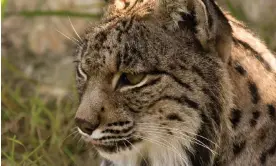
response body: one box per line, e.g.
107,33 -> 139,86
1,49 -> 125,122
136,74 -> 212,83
174,0 -> 232,63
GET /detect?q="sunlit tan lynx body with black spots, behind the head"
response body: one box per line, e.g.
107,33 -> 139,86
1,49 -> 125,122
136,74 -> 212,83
221,16 -> 276,166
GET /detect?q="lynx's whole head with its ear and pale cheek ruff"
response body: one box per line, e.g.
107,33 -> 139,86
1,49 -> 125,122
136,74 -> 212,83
75,0 -> 231,166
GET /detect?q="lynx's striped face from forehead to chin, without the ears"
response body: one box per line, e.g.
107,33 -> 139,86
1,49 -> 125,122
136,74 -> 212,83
76,18 -> 229,165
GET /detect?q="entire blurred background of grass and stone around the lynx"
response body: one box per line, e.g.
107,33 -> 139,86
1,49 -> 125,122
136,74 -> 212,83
1,0 -> 276,166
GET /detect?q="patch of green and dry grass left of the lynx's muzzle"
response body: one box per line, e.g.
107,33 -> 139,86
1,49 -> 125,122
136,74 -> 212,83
1,57 -> 99,166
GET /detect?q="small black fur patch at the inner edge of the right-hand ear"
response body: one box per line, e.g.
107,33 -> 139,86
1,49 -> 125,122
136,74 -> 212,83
178,11 -> 197,33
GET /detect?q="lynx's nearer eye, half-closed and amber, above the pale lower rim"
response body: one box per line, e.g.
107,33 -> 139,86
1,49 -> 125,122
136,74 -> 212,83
118,73 -> 146,86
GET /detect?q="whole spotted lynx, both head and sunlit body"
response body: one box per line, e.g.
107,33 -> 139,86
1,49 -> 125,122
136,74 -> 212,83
75,0 -> 276,166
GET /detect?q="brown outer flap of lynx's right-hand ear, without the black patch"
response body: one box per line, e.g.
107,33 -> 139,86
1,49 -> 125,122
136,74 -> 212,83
193,0 -> 232,62
